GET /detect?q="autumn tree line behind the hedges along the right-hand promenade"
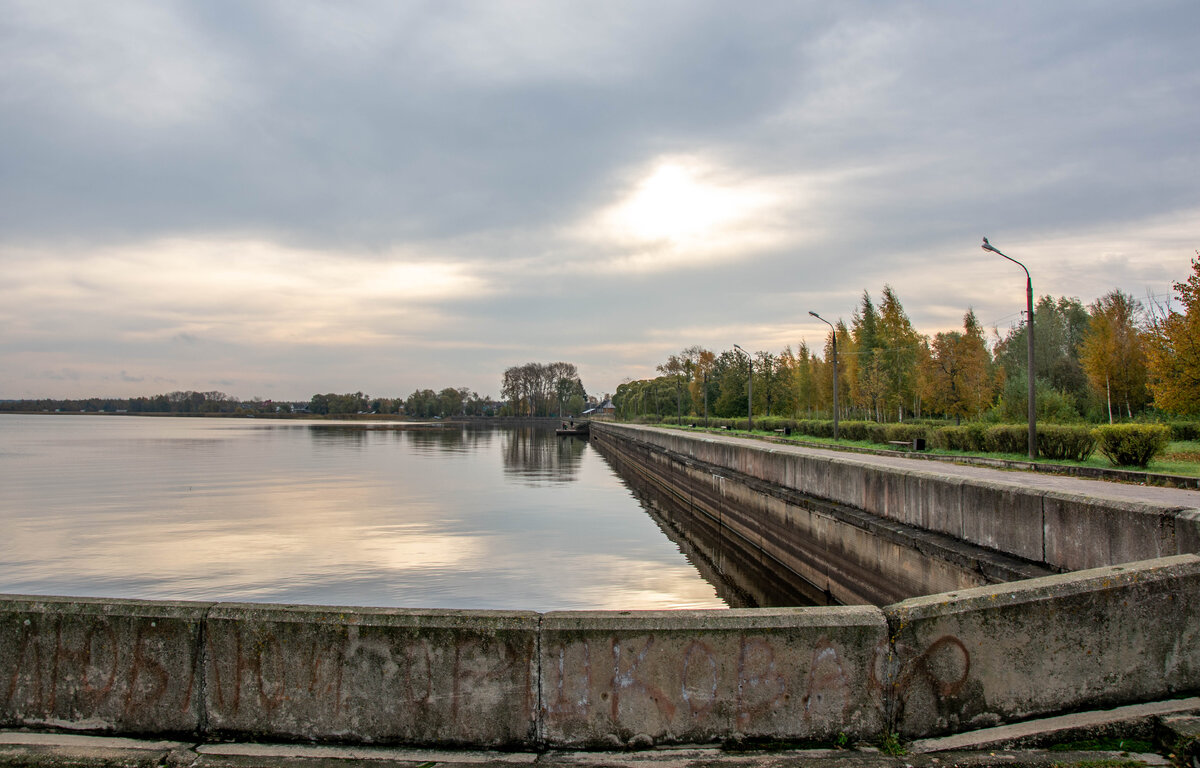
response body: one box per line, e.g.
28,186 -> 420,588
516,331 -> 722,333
613,252 -> 1200,424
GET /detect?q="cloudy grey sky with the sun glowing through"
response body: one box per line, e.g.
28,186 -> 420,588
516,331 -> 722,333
0,0 -> 1200,400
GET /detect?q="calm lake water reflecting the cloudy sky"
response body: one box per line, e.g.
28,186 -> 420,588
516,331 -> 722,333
0,415 -> 725,611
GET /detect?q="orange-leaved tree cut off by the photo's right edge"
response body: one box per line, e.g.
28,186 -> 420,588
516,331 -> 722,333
1147,251 -> 1200,416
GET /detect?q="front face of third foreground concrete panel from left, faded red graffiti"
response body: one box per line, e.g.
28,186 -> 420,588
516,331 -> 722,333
542,631 -> 882,743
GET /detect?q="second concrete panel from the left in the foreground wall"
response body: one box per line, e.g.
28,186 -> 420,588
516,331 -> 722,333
205,605 -> 538,746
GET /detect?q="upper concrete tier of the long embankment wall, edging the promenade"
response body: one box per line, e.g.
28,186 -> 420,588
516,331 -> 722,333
593,422 -> 1200,571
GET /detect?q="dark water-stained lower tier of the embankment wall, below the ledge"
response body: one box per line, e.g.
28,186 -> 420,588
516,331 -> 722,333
592,431 -> 1054,605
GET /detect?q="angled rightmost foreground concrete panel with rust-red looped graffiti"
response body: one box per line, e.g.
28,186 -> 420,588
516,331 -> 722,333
884,554 -> 1200,737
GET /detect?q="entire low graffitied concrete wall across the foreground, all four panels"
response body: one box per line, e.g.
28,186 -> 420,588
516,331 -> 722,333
0,556 -> 1200,749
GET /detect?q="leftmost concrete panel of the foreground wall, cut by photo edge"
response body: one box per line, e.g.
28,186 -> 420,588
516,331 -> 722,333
0,595 -> 206,734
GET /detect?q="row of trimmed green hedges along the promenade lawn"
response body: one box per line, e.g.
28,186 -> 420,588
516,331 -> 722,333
664,416 -> 1180,467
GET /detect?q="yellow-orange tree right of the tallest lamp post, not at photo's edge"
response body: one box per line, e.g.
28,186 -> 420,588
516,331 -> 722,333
1079,290 -> 1150,424
